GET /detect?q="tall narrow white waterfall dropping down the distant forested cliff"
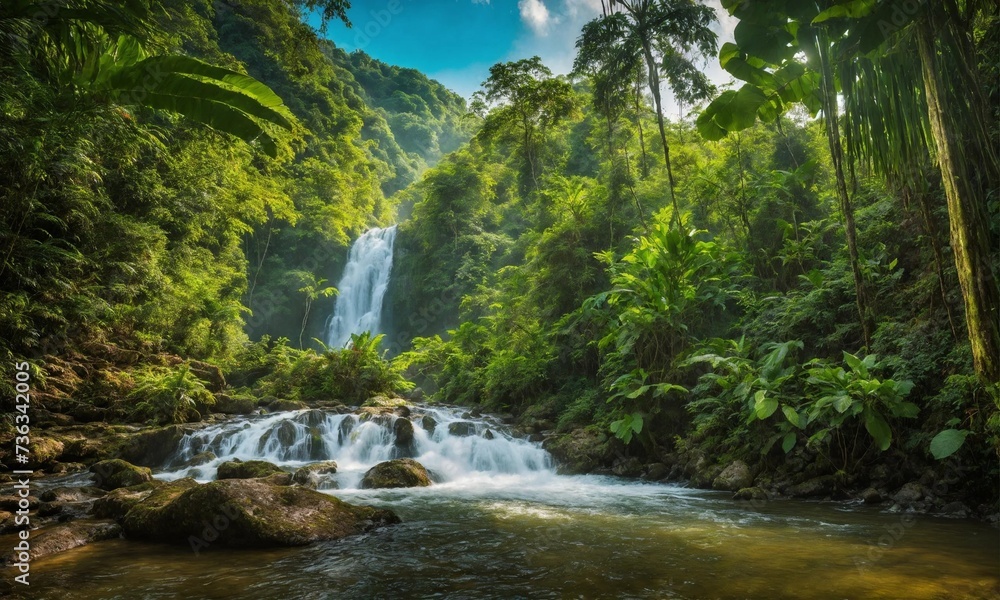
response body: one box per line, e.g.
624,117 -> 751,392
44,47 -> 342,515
326,225 -> 396,348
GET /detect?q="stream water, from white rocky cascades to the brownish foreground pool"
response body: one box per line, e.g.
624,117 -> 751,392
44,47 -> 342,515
19,408 -> 1000,600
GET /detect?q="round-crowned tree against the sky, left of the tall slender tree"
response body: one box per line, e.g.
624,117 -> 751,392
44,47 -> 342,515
471,56 -> 575,190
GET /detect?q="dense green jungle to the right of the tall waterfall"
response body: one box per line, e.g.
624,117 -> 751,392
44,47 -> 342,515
388,2 -> 1000,503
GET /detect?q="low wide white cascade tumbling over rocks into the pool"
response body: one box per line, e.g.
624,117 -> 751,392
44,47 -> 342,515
157,407 -> 554,489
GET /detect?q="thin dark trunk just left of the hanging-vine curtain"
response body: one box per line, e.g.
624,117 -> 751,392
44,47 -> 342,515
816,33 -> 873,348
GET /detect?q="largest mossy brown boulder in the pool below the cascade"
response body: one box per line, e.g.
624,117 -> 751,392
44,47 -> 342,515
122,479 -> 399,552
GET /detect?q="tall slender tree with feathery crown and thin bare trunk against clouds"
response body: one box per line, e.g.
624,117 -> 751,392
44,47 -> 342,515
576,0 -> 717,226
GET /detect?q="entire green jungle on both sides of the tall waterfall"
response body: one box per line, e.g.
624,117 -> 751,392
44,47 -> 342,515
0,0 -> 1000,552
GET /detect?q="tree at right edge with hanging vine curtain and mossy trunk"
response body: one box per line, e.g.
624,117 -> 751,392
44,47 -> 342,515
813,0 -> 1000,382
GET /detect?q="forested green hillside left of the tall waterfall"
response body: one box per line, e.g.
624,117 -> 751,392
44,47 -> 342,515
0,0 -> 471,414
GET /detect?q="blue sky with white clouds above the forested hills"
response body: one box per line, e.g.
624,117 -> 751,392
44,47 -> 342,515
316,0 -> 735,112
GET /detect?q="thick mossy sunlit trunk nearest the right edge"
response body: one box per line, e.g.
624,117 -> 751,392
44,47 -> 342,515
917,19 -> 1000,382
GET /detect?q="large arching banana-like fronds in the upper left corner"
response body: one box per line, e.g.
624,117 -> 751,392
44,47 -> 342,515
0,0 -> 294,158
